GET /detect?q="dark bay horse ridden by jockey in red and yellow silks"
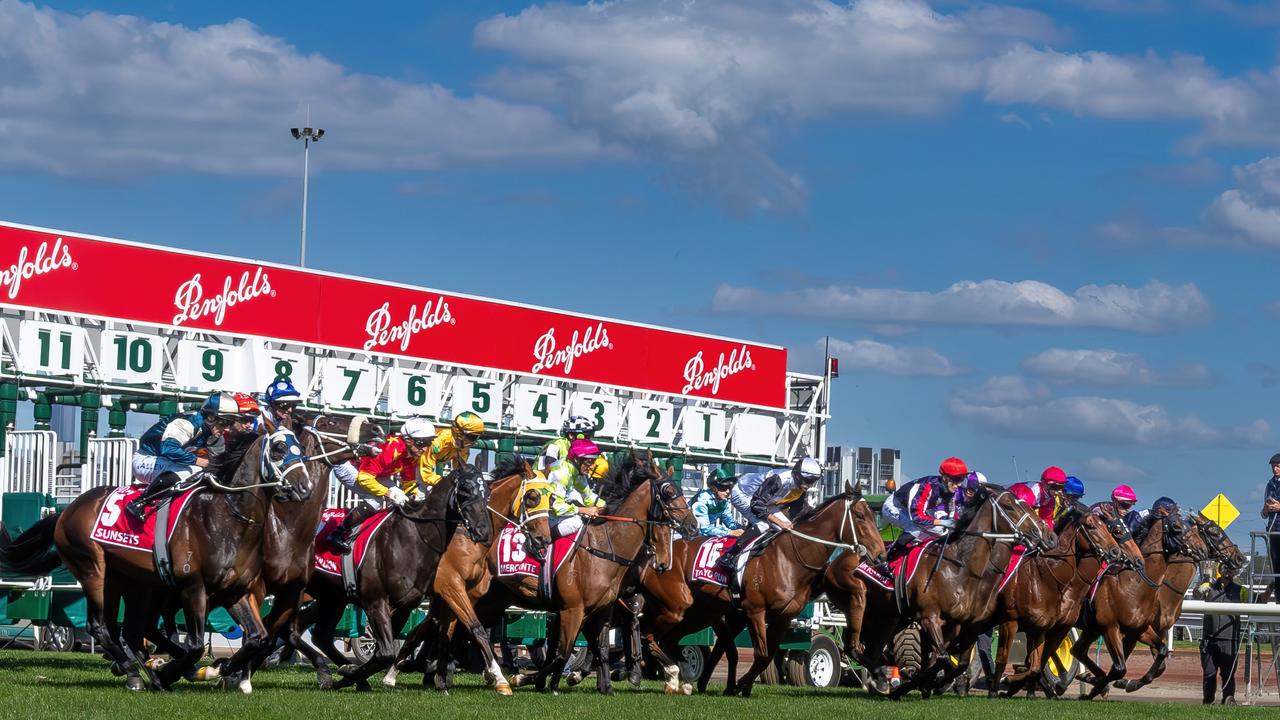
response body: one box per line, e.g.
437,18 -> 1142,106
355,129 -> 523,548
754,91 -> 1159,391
307,465 -> 490,691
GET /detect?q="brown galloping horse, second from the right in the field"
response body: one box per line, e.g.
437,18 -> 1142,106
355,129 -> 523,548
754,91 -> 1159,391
1071,504 -> 1206,700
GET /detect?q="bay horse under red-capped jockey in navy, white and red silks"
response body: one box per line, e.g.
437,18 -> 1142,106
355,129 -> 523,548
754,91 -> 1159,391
893,484 -> 1056,697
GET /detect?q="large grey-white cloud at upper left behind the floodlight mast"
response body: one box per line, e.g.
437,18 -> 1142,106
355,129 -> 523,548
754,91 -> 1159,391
0,0 -> 605,179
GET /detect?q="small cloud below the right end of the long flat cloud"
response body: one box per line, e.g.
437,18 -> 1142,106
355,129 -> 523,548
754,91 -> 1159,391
1021,347 -> 1210,387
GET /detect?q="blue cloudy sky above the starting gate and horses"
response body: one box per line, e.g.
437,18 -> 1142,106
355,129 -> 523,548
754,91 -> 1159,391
0,0 -> 1280,542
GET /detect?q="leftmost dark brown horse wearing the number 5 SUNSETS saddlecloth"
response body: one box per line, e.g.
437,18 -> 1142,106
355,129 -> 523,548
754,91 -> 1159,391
3,433 -> 314,692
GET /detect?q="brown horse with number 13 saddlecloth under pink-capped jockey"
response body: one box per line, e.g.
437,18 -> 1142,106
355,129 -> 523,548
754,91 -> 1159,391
435,448 -> 698,694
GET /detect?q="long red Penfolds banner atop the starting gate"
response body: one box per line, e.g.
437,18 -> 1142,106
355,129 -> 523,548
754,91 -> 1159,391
0,223 -> 787,407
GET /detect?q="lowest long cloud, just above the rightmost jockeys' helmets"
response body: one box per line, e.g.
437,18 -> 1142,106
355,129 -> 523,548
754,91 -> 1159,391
948,384 -> 1271,447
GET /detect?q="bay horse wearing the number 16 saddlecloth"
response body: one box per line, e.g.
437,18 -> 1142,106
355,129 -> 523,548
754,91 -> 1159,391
643,486 -> 884,697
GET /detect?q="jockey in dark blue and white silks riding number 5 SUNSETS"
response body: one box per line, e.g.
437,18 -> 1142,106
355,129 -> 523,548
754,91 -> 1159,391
124,392 -> 259,520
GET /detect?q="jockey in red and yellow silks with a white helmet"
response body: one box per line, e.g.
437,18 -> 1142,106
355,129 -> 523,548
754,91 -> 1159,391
329,418 -> 435,552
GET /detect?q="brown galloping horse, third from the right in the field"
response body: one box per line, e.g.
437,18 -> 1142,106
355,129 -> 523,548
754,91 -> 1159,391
987,507 -> 1138,697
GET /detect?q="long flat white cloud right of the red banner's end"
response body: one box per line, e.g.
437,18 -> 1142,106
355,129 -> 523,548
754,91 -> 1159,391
712,279 -> 1210,333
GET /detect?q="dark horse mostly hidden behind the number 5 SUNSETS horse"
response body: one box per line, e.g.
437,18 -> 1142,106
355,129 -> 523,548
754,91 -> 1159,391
213,411 -> 380,687
